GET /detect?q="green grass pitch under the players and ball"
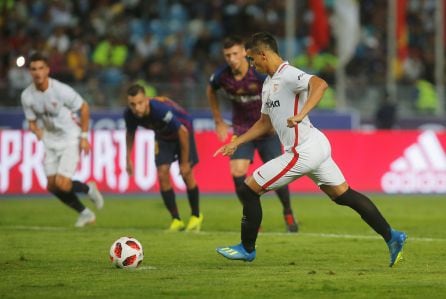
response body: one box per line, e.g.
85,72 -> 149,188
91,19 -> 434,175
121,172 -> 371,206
0,195 -> 446,298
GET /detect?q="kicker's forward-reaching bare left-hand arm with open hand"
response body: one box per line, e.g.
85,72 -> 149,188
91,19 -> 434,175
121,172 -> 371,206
214,113 -> 273,157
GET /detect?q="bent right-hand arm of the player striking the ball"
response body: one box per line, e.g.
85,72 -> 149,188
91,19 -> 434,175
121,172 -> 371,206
287,76 -> 328,128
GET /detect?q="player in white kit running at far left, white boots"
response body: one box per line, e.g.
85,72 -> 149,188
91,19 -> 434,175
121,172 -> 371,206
21,52 -> 104,227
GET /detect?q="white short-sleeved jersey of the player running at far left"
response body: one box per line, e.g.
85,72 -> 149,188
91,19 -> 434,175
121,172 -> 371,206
21,78 -> 84,147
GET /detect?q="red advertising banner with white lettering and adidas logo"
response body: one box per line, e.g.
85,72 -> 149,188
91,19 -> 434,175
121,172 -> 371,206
0,130 -> 446,194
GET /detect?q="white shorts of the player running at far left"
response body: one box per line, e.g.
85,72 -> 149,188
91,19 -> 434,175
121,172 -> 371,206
43,143 -> 80,178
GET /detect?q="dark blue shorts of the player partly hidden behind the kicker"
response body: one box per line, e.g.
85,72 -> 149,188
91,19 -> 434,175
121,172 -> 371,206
231,134 -> 282,162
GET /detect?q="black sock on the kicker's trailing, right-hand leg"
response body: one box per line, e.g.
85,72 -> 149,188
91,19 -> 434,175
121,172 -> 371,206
334,188 -> 391,242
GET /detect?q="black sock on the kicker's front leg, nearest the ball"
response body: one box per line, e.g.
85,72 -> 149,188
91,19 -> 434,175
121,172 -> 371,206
237,184 -> 262,252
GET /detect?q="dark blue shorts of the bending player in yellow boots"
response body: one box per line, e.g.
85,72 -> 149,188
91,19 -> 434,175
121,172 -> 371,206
155,133 -> 198,167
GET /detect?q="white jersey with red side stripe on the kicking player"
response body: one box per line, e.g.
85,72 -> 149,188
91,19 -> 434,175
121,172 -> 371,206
261,62 -> 317,152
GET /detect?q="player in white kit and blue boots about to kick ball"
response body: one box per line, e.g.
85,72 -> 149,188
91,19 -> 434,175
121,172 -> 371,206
214,32 -> 407,267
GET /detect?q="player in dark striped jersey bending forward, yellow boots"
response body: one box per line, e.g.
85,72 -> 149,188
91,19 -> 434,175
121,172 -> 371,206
124,84 -> 203,231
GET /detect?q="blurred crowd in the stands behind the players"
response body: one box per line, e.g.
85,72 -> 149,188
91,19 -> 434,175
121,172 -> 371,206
0,0 -> 435,112
